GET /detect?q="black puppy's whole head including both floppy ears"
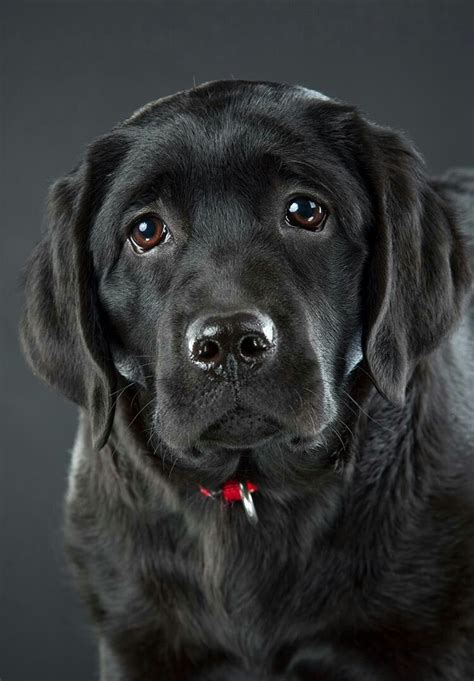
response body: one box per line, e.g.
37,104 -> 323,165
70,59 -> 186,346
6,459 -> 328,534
23,81 -> 468,488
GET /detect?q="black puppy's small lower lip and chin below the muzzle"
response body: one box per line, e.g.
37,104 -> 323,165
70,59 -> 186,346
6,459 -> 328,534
200,408 -> 282,449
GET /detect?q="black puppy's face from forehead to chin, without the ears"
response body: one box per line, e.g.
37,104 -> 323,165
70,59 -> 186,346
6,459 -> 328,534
97,86 -> 370,478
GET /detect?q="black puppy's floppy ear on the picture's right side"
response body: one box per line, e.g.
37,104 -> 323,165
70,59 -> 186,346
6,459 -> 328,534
363,125 -> 470,404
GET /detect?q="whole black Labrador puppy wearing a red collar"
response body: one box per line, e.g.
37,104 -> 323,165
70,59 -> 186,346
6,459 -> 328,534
22,81 -> 474,681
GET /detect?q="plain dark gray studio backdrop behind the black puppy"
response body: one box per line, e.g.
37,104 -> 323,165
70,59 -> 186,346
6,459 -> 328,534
0,0 -> 474,681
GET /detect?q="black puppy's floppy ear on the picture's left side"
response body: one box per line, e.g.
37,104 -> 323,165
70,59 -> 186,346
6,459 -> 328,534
21,138 -> 129,449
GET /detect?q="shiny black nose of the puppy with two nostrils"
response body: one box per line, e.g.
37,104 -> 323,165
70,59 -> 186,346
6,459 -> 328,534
186,312 -> 276,370
